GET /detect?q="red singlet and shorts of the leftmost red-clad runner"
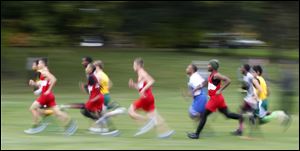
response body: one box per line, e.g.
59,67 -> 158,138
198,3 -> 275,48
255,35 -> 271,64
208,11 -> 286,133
36,74 -> 56,107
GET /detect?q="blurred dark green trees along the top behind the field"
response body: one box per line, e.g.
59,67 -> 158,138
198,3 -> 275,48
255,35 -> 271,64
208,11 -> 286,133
1,1 -> 299,48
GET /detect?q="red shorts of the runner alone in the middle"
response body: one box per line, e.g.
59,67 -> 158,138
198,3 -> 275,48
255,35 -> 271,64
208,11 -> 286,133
133,94 -> 155,112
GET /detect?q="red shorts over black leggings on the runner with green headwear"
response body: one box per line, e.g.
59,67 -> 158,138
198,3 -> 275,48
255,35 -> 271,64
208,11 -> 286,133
205,94 -> 227,112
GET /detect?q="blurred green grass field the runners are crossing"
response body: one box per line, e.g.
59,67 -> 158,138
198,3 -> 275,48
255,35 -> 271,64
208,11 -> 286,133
1,48 -> 299,150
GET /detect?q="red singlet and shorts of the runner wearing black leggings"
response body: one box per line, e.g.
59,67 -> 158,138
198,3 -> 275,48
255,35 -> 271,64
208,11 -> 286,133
205,72 -> 227,112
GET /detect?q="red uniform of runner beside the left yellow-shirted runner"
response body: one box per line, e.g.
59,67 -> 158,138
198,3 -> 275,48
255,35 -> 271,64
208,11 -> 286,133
85,74 -> 104,112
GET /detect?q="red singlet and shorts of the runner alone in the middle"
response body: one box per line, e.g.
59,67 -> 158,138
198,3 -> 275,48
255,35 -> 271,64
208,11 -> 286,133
133,82 -> 155,112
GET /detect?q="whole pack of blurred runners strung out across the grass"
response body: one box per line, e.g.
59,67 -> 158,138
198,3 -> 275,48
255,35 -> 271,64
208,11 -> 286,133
24,57 -> 290,139
